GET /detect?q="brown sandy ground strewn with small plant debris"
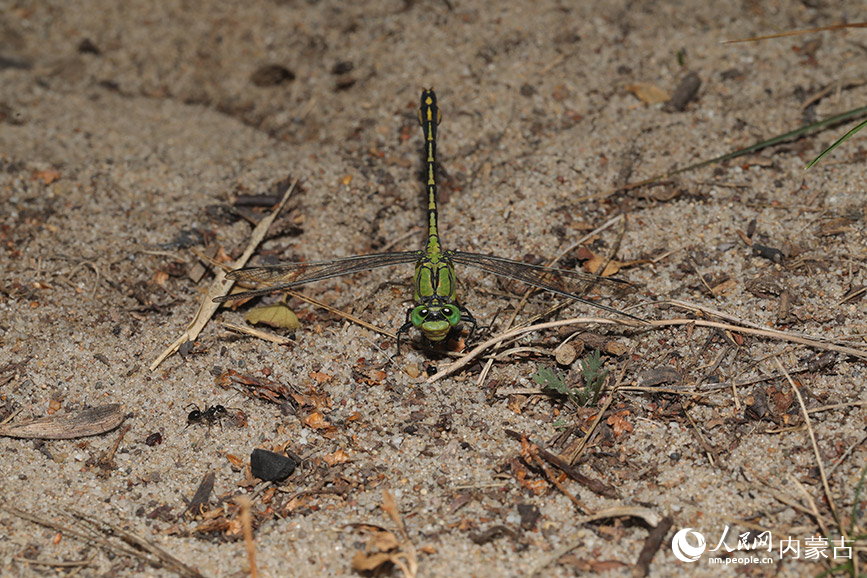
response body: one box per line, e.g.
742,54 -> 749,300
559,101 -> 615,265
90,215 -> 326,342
0,0 -> 867,577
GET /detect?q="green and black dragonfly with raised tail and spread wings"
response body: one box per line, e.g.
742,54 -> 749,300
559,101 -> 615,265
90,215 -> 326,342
214,89 -> 639,352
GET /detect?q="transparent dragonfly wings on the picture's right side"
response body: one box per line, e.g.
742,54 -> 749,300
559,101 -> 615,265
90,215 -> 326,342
446,251 -> 639,319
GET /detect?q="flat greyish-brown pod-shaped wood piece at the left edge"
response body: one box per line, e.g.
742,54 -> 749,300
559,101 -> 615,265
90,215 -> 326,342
0,403 -> 124,440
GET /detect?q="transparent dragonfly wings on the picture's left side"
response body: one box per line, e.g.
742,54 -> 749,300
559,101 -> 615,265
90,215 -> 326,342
214,251 -> 424,303
